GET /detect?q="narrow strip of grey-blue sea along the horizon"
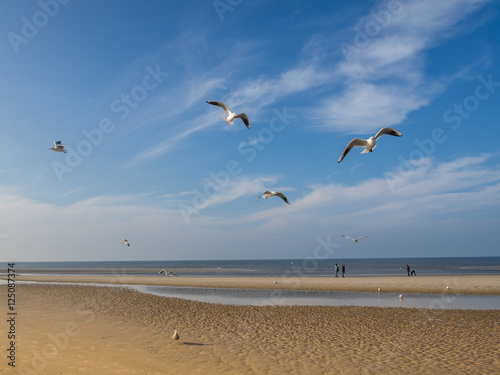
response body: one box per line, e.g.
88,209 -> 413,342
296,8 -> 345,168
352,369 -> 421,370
0,257 -> 500,276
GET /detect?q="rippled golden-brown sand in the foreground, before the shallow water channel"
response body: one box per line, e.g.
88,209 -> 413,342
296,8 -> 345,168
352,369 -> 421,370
0,284 -> 500,375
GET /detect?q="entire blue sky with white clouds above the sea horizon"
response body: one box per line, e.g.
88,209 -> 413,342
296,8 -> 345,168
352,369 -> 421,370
0,0 -> 500,261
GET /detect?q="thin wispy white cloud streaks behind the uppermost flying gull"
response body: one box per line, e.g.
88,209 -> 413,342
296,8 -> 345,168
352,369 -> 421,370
125,32 -> 334,164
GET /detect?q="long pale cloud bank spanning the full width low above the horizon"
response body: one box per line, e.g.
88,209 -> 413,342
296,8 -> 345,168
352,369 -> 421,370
0,155 -> 500,260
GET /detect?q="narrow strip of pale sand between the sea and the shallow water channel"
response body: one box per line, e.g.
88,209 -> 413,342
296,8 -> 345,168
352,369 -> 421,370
0,274 -> 500,295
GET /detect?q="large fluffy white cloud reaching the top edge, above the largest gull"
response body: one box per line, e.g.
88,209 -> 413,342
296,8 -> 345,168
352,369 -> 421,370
315,0 -> 488,132
